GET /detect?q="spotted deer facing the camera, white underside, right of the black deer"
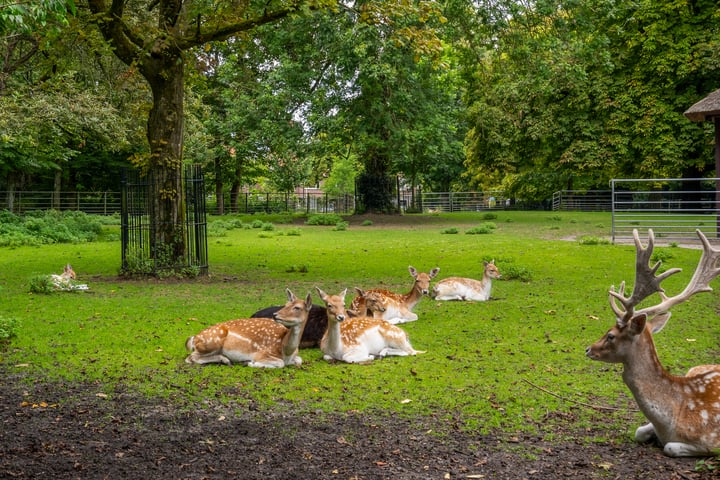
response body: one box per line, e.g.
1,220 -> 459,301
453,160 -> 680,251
315,287 -> 424,363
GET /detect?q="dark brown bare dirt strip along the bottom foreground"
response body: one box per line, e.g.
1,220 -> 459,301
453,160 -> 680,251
0,376 -> 720,480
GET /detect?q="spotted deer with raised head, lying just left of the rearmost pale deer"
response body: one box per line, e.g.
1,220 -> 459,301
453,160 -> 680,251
350,265 -> 440,324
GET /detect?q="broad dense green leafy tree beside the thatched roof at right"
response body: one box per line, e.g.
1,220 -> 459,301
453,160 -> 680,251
467,0 -> 720,200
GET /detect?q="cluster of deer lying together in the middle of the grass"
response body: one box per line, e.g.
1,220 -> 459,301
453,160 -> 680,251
185,262 -> 500,367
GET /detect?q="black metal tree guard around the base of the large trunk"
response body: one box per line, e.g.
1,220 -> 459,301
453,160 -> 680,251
120,165 -> 208,275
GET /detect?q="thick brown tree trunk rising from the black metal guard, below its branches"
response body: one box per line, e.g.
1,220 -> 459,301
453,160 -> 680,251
141,50 -> 187,266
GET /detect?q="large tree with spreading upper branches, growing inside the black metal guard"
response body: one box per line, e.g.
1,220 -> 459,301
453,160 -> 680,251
88,0 -> 330,264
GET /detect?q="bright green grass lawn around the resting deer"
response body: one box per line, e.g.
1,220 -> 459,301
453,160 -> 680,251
0,212 -> 720,440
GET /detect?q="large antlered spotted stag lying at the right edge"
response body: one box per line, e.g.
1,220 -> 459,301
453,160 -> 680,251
585,230 -> 720,457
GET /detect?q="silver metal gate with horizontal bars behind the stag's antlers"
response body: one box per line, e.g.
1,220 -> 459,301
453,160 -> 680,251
611,178 -> 720,243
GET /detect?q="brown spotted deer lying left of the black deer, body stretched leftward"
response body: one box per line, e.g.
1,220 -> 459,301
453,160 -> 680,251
185,289 -> 312,368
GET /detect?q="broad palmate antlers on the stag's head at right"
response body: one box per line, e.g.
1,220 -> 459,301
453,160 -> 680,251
609,230 -> 720,324
